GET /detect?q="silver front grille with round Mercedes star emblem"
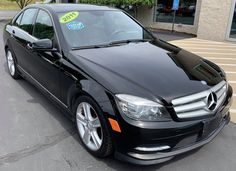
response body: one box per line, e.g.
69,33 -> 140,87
171,81 -> 227,119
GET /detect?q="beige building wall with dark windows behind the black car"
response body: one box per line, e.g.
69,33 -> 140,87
137,0 -> 236,41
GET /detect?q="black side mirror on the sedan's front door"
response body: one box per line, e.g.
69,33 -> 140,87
27,39 -> 56,51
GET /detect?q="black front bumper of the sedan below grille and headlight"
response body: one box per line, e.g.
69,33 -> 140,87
114,87 -> 232,165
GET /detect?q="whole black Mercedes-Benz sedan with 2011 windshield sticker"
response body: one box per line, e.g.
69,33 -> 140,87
4,4 -> 232,165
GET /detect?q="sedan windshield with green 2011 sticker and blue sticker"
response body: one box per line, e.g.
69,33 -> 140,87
58,11 -> 152,48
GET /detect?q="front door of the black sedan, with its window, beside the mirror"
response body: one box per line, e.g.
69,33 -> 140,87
29,10 -> 60,100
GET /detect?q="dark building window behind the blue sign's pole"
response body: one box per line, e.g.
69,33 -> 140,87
155,0 -> 197,25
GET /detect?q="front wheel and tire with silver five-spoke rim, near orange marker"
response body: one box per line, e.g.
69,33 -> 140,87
73,95 -> 113,158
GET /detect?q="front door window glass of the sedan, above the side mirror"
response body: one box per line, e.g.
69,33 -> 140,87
34,10 -> 54,39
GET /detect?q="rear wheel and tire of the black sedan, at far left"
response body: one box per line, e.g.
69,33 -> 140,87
6,49 -> 20,79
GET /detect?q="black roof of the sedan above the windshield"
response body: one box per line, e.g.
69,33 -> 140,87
31,3 -> 117,12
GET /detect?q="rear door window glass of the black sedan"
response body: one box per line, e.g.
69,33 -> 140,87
19,9 -> 37,34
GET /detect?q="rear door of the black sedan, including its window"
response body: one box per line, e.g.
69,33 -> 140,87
10,8 -> 37,73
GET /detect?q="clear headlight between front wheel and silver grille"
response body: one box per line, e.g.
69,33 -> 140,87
116,94 -> 170,121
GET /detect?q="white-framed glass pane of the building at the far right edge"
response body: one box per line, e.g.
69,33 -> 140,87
228,0 -> 236,40
